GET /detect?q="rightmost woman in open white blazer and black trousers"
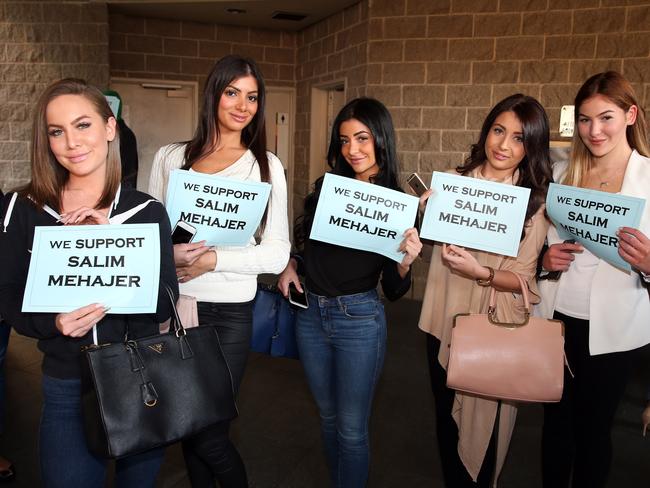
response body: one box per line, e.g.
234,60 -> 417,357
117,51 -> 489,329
538,71 -> 650,488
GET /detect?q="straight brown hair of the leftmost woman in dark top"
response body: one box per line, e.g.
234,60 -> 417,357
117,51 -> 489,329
19,78 -> 122,210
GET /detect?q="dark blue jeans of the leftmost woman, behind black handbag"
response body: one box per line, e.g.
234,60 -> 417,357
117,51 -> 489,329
39,375 -> 165,488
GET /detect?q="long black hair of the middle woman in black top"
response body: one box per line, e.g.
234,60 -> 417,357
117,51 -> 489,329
294,97 -> 402,248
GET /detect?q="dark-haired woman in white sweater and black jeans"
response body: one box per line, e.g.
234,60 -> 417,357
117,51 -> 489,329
149,55 -> 291,488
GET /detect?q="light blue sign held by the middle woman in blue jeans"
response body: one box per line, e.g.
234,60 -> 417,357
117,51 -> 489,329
309,173 -> 418,263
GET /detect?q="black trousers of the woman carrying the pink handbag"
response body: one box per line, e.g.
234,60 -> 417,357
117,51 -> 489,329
427,334 -> 498,488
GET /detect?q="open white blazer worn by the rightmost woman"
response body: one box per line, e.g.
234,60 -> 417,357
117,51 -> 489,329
535,151 -> 650,356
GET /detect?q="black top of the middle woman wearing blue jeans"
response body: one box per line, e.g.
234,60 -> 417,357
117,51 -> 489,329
300,239 -> 411,300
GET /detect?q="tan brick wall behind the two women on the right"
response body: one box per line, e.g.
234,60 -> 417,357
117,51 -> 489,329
367,0 -> 650,297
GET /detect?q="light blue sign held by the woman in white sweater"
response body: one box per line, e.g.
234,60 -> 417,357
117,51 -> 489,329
165,169 -> 271,246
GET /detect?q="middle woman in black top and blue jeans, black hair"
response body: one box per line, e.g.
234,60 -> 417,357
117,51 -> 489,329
279,98 -> 422,488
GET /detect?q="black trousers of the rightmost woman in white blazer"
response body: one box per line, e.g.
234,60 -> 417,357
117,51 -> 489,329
542,312 -> 636,488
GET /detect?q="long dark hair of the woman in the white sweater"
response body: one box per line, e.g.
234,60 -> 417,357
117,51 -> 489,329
178,54 -> 271,182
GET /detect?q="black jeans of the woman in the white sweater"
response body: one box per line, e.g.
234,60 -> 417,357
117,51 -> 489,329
183,301 -> 253,488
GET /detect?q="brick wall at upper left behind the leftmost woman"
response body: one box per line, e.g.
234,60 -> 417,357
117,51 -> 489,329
0,0 -> 108,191
